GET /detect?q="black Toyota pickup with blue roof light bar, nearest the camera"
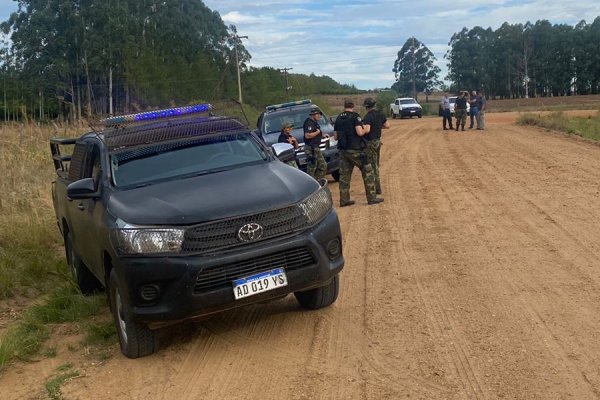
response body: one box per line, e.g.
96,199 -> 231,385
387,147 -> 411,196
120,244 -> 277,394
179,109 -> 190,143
50,104 -> 344,358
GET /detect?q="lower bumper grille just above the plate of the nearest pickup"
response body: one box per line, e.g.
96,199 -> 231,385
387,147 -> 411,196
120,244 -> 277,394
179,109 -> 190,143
194,247 -> 315,294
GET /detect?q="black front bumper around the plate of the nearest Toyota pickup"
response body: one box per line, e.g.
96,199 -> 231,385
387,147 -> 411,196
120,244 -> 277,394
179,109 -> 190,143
115,210 -> 344,327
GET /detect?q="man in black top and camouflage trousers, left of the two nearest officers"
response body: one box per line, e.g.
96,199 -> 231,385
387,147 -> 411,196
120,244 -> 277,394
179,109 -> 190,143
334,99 -> 383,207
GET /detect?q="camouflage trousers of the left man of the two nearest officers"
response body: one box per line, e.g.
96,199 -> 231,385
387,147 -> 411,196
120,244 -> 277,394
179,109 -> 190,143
340,150 -> 376,204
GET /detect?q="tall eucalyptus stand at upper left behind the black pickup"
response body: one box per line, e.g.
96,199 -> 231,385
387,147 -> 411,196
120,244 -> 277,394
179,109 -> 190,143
2,0 -> 247,116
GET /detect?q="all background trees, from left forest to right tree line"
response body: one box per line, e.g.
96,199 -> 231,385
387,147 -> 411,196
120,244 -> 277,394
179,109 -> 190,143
0,0 -> 600,121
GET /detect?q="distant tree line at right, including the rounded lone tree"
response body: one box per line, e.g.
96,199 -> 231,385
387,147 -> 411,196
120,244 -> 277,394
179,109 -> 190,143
392,17 -> 600,98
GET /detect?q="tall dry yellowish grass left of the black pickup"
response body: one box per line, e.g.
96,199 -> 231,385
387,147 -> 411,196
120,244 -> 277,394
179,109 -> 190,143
0,124 -> 82,299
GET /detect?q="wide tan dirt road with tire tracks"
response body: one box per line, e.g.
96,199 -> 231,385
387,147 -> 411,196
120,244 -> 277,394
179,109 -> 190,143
0,113 -> 600,400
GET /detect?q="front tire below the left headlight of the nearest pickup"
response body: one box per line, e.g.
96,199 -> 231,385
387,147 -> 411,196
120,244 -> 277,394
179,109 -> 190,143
108,269 -> 158,358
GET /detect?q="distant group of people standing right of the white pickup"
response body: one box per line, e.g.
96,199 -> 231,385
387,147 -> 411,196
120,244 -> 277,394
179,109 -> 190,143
440,90 -> 486,131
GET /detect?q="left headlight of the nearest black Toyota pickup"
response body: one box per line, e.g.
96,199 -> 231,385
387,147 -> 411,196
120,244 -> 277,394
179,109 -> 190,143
115,227 -> 185,254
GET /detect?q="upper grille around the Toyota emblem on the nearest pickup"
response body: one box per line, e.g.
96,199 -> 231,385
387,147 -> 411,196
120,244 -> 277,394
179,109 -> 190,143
181,205 -> 308,253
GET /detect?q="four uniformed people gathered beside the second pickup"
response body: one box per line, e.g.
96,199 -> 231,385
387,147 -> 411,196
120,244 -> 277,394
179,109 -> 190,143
278,97 -> 390,207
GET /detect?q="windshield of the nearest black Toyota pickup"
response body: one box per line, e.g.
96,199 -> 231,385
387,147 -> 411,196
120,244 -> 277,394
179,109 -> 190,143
110,134 -> 268,187
